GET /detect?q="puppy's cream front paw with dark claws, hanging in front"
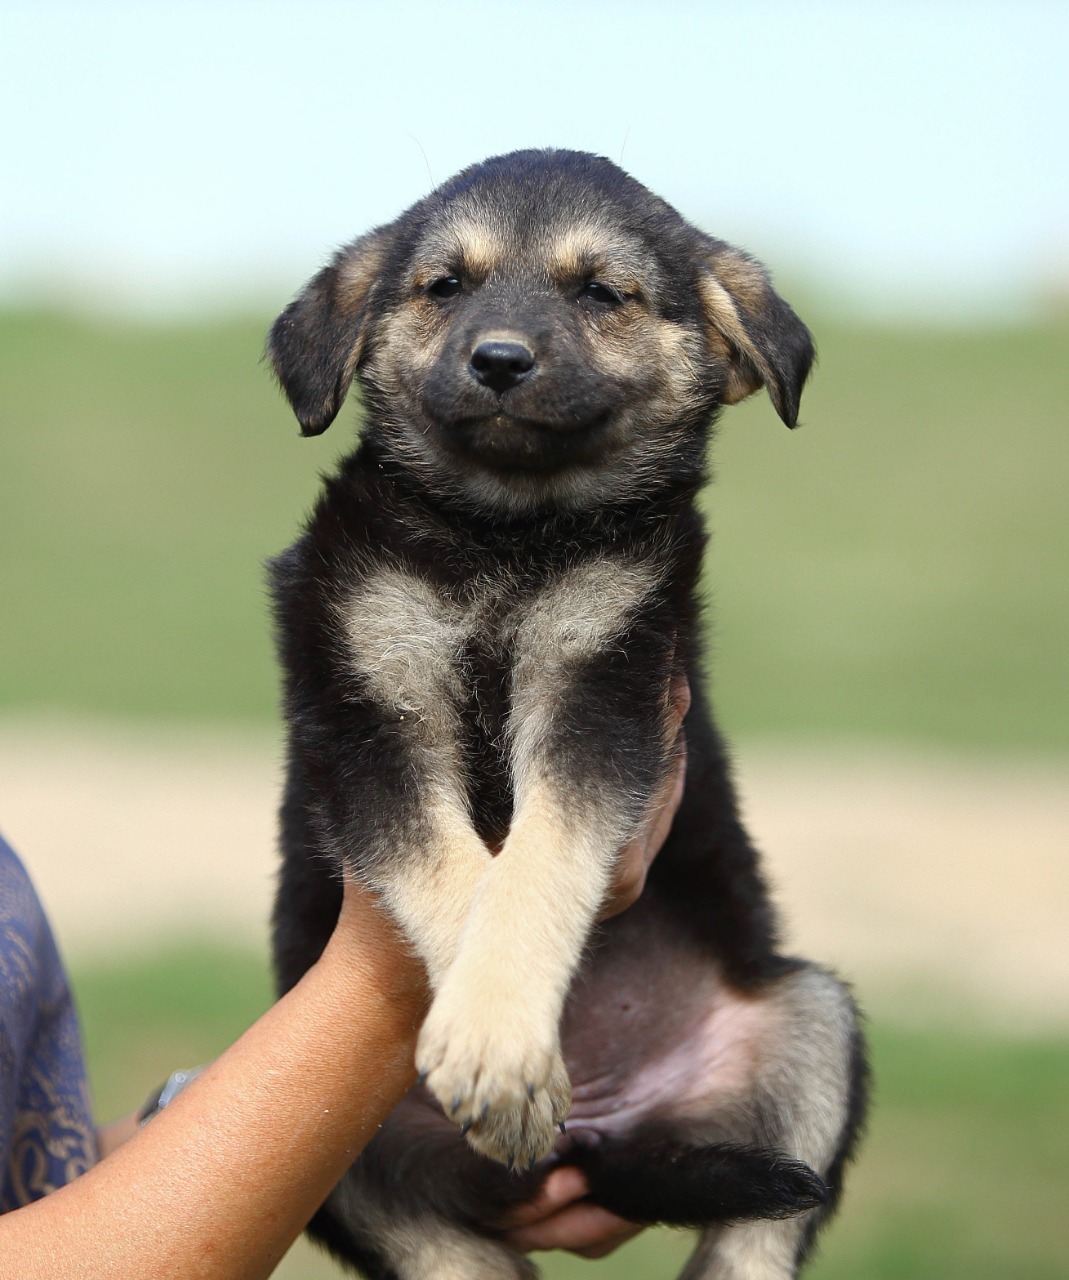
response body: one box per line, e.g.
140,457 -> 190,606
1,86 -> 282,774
416,987 -> 571,1165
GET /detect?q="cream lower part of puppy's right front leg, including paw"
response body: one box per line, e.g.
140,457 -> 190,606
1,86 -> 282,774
416,762 -> 623,1164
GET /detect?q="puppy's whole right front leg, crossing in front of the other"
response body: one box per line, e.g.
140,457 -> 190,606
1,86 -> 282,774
416,562 -> 671,1162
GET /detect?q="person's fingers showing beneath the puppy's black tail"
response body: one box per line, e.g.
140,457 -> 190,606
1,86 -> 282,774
504,1165 -> 641,1258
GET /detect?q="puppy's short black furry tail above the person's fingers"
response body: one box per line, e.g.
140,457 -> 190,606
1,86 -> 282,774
563,1135 -> 830,1226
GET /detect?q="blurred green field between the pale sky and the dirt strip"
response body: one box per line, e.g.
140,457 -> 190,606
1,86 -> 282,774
0,311 -> 1069,753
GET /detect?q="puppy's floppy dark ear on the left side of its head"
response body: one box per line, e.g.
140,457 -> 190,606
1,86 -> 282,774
268,227 -> 393,435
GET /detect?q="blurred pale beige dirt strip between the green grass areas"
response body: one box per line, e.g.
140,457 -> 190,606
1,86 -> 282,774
0,721 -> 1069,1028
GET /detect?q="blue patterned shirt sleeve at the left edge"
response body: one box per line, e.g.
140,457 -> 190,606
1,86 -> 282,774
0,837 -> 97,1212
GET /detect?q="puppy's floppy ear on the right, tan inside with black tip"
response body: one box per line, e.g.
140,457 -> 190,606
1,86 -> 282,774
699,237 -> 816,426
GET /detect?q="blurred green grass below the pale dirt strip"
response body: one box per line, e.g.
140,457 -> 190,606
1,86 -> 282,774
74,941 -> 1069,1280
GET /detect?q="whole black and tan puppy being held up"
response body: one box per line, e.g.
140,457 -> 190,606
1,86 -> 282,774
269,151 -> 864,1280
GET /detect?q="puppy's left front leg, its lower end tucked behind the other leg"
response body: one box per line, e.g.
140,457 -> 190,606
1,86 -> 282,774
324,568 -> 490,989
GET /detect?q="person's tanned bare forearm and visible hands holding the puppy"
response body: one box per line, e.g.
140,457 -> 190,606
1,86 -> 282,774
0,698 -> 685,1280
